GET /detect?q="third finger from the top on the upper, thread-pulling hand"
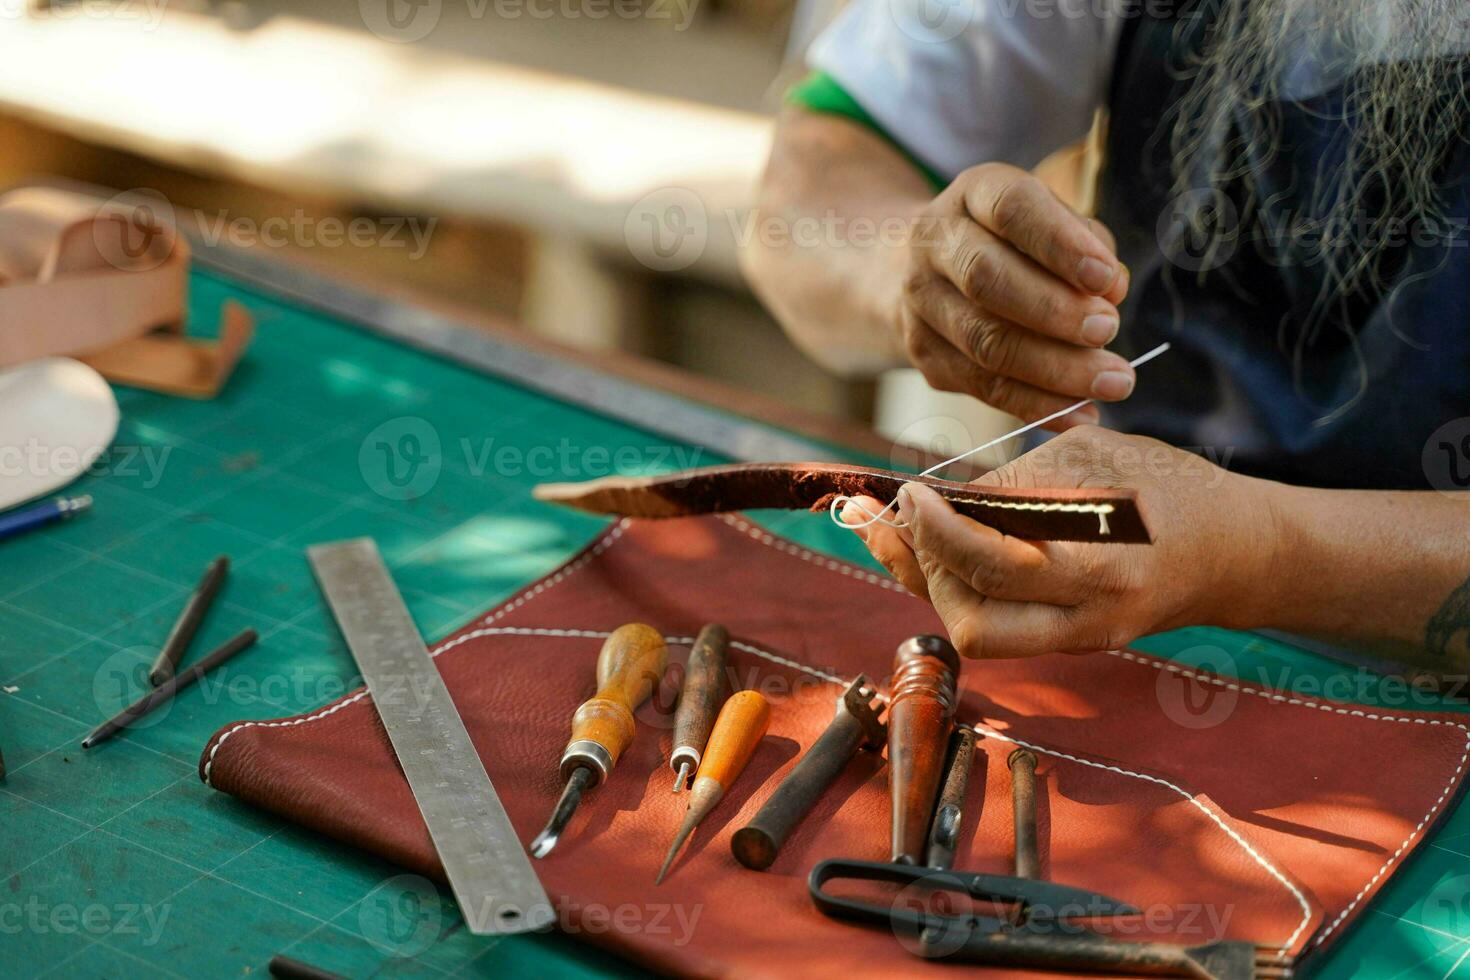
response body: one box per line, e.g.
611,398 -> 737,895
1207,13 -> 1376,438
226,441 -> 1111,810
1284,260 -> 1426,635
910,279 -> 1135,401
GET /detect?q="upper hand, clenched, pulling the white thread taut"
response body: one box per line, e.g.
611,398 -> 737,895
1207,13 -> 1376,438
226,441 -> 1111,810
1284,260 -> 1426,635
897,163 -> 1133,430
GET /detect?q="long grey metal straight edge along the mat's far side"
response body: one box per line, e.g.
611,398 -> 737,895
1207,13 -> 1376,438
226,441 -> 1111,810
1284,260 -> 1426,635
190,235 -> 844,463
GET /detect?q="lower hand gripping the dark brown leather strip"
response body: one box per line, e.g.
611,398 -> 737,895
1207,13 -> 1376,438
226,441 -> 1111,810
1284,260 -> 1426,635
842,426 -> 1279,658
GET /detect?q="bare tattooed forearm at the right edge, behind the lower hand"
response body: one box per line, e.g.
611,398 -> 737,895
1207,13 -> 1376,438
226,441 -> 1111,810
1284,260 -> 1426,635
1234,483 -> 1470,673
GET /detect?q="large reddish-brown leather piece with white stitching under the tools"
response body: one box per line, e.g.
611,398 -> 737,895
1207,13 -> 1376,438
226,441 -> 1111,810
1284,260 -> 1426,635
200,517 -> 1467,979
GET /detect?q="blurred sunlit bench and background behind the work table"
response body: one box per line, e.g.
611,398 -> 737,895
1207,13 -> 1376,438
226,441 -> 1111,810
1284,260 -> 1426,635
0,0 -> 1046,444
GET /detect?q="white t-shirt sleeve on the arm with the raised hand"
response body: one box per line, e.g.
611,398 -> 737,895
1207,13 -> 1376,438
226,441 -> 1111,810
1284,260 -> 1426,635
807,0 -> 1123,179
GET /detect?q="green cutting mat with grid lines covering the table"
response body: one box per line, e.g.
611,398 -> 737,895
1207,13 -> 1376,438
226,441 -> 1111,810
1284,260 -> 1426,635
0,264 -> 1470,979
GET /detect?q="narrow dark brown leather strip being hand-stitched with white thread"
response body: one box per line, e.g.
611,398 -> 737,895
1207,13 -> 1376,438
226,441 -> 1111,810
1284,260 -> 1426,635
534,463 -> 1150,544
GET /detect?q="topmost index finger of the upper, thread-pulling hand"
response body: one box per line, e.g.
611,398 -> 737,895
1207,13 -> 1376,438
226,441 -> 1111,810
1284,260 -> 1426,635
964,166 -> 1122,295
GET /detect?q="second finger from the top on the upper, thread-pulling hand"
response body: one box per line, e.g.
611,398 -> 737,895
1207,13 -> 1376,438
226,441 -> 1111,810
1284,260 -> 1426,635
926,222 -> 1119,347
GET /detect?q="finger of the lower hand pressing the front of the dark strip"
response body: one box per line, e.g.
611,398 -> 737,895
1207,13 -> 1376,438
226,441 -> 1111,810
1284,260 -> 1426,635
898,483 -> 1086,605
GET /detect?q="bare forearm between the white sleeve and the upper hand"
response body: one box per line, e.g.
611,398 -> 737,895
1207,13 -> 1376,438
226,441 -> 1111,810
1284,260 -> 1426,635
741,109 -> 933,375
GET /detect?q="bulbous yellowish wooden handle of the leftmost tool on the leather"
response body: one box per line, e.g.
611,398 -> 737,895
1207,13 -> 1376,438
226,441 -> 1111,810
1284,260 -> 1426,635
562,623 -> 669,779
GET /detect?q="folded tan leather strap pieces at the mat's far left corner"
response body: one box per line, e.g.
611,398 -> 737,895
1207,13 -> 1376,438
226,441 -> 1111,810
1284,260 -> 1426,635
0,187 -> 254,398
